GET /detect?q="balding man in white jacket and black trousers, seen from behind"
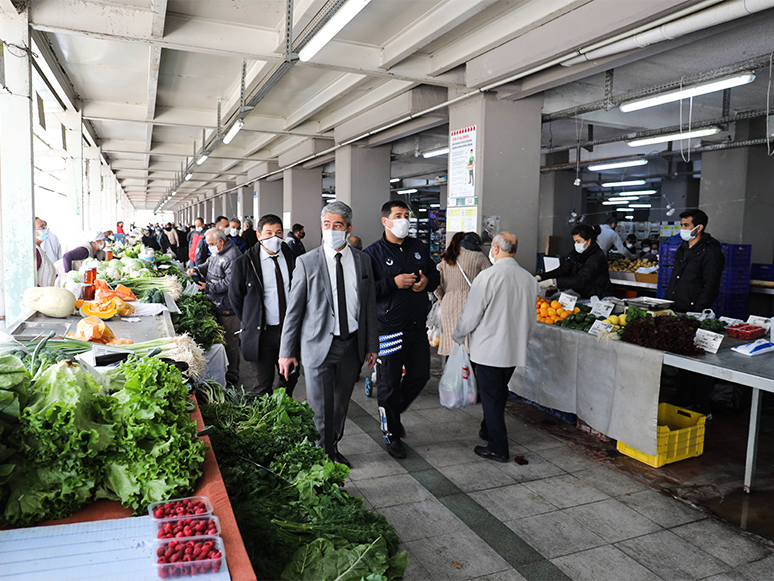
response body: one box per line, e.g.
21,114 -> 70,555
452,232 -> 538,462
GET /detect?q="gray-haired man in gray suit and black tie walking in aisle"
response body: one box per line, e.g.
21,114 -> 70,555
279,202 -> 379,466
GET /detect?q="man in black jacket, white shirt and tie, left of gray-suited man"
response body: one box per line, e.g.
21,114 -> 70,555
228,214 -> 298,396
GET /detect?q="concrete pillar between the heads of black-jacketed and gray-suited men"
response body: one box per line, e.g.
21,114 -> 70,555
282,167 -> 323,250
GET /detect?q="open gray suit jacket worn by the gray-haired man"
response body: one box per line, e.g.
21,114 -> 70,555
279,246 -> 379,367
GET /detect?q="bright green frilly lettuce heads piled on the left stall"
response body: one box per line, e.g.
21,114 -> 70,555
0,357 -> 204,526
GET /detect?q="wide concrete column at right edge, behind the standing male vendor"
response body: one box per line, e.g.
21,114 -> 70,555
699,119 -> 774,264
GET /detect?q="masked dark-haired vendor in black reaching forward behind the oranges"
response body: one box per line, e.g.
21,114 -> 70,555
537,224 -> 613,299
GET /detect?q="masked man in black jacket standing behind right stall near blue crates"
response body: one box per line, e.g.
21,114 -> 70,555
666,210 -> 726,313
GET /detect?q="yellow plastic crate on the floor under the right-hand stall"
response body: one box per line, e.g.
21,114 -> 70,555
617,403 -> 707,468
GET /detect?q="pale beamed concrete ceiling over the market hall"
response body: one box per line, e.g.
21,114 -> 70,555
12,0 -> 774,209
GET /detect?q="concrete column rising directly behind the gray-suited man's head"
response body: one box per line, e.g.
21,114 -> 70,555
336,145 -> 391,248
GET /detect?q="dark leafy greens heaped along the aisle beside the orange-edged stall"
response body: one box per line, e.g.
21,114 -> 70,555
201,389 -> 406,581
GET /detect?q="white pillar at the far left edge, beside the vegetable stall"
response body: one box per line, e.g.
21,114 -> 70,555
0,4 -> 37,324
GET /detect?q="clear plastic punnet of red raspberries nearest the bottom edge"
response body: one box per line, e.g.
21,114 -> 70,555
154,537 -> 229,579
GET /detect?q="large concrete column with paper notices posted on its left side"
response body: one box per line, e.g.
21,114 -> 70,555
447,90 -> 543,271
